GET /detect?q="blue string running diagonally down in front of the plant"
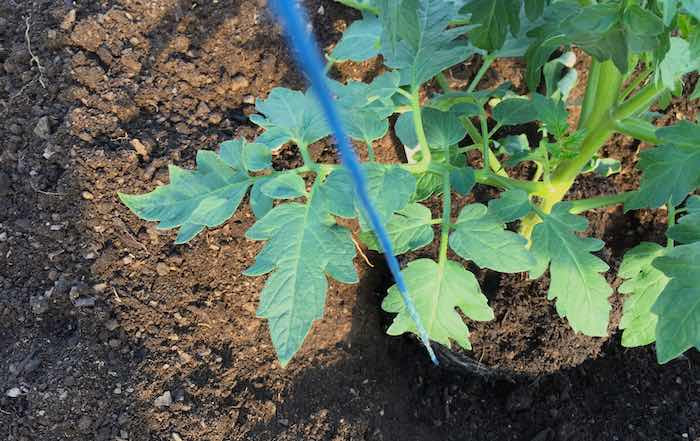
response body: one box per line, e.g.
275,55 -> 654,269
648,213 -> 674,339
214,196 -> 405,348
270,0 -> 438,364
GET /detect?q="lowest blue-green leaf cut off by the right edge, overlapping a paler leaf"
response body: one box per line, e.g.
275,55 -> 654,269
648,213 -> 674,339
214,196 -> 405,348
651,242 -> 700,364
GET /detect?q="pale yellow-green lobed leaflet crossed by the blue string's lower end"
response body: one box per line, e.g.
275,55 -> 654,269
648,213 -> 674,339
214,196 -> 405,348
382,259 -> 494,349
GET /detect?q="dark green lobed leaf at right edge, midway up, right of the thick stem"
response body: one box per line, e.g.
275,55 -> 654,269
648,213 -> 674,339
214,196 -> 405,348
625,122 -> 700,210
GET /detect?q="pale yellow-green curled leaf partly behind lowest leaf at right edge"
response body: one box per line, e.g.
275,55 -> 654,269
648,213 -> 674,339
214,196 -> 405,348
618,242 -> 668,348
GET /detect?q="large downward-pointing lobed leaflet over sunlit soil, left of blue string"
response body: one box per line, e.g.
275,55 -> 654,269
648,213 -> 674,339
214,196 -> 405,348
245,186 -> 358,366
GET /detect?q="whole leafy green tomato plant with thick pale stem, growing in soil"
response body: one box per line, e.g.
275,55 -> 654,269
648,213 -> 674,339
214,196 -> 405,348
120,0 -> 700,365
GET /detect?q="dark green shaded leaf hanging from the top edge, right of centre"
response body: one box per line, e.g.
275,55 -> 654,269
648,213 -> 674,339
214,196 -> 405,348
460,0 -> 524,52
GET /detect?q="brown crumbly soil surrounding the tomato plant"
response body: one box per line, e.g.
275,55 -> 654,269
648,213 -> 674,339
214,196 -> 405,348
0,0 -> 700,441
